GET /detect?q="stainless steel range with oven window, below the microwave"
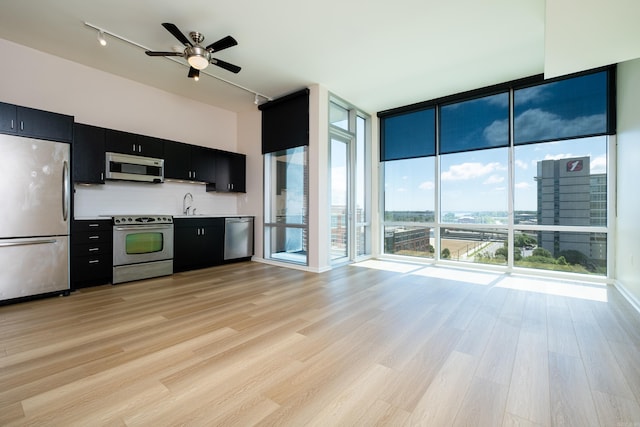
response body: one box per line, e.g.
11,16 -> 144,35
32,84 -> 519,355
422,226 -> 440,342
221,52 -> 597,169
113,215 -> 173,284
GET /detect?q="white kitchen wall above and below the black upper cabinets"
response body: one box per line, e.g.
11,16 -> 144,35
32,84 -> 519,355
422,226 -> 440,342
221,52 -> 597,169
0,39 -> 262,217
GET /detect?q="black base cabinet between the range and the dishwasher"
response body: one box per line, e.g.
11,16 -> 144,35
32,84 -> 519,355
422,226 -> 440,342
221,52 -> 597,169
173,217 -> 224,272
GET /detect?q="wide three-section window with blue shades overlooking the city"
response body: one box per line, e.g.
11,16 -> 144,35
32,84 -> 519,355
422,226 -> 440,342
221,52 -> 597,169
379,68 -> 615,276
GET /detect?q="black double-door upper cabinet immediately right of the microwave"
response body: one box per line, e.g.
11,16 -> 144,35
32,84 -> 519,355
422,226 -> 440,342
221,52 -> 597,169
164,141 -> 216,183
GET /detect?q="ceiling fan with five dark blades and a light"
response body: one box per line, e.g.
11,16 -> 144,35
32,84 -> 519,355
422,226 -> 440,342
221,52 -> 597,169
145,22 -> 241,80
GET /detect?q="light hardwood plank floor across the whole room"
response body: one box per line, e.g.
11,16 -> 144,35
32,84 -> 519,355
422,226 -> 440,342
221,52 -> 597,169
0,261 -> 640,427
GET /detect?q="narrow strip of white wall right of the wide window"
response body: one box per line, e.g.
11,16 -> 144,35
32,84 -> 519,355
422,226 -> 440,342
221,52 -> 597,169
614,59 -> 640,310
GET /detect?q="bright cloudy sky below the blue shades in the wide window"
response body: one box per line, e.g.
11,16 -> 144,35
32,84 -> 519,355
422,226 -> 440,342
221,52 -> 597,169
385,137 -> 607,213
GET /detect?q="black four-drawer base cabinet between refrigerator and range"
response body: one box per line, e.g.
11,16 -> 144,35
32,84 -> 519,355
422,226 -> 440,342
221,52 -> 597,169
70,219 -> 113,289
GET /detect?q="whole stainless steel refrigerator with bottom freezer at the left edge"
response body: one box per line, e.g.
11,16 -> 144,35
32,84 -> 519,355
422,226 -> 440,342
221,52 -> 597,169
0,135 -> 71,301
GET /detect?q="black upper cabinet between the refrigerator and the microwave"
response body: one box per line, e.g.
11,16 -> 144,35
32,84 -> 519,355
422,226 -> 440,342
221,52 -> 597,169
71,123 -> 106,184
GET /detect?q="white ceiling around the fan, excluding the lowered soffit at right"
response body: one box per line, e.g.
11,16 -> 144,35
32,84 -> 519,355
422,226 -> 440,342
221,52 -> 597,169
0,0 -> 636,113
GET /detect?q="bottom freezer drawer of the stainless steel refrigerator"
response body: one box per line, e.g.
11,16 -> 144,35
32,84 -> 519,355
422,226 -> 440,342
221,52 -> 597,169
0,236 -> 69,300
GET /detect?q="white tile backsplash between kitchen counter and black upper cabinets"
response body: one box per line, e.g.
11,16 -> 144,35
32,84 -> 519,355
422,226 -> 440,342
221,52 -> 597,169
74,181 -> 238,218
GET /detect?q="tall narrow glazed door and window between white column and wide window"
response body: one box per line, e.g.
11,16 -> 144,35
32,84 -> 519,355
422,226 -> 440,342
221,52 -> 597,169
329,96 -> 371,264
